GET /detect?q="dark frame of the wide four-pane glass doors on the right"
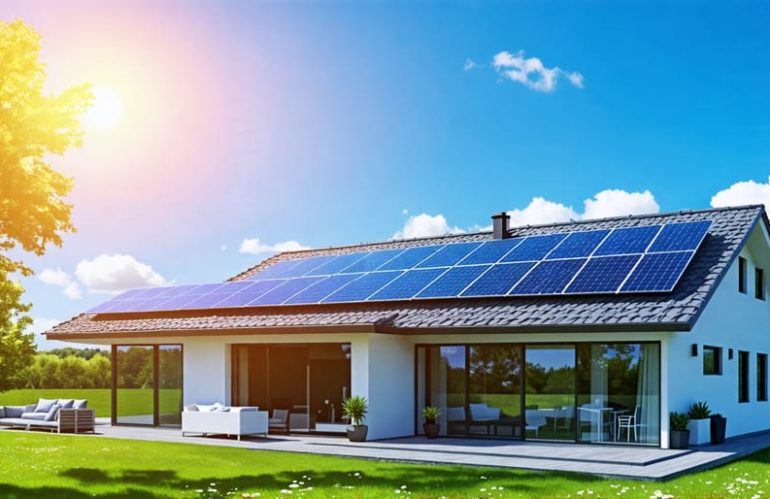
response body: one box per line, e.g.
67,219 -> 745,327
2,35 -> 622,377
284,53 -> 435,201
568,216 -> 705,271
414,340 -> 664,448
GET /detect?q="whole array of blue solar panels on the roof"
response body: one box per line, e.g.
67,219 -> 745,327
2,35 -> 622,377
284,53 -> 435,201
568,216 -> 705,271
89,220 -> 711,313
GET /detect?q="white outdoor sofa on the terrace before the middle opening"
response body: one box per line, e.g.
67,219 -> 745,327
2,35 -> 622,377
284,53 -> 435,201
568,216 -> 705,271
182,404 -> 268,441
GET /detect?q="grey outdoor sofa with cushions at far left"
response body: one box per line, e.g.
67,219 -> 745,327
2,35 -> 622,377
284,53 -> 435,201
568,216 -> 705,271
0,399 -> 96,433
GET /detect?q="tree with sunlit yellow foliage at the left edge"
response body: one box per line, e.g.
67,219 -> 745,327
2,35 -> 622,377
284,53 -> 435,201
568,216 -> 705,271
0,21 -> 92,391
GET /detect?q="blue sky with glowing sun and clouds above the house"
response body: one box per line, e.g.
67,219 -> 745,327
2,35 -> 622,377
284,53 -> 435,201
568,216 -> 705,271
0,0 -> 770,348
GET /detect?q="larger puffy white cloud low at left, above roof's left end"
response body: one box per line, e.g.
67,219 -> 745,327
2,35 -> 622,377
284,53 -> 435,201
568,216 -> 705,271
75,254 -> 167,294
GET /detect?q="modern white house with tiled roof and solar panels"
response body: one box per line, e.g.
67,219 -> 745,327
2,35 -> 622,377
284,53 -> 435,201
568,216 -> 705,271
47,206 -> 770,448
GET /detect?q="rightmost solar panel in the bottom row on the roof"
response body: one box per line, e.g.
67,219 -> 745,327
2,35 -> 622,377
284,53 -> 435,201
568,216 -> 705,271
621,251 -> 694,292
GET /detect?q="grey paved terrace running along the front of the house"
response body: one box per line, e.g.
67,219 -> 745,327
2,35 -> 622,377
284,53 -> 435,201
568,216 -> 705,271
2,424 -> 770,480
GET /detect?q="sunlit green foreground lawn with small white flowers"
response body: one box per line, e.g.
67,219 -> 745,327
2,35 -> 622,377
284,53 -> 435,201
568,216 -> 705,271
0,431 -> 770,498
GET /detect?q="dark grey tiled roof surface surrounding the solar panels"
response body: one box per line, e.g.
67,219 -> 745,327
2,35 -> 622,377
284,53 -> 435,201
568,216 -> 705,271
47,206 -> 770,339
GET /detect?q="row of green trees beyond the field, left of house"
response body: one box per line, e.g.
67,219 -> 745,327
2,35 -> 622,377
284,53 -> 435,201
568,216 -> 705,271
13,349 -> 112,388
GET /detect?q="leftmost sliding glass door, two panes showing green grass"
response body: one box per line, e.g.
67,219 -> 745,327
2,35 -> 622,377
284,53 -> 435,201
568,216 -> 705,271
112,345 -> 182,426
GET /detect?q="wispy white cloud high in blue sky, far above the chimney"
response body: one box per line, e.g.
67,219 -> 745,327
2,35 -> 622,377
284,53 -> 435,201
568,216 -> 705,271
492,50 -> 583,92
